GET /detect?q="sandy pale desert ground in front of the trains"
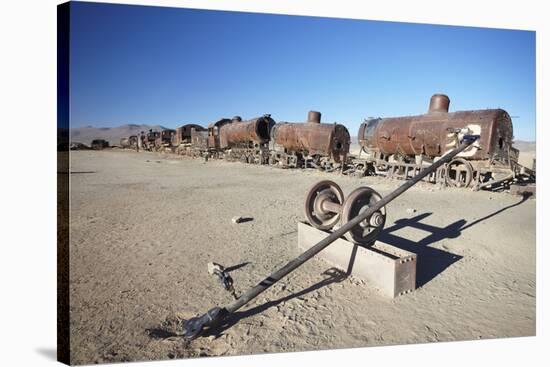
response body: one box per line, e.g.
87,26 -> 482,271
70,151 -> 536,364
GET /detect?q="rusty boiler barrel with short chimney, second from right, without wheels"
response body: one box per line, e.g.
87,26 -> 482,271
271,111 -> 350,162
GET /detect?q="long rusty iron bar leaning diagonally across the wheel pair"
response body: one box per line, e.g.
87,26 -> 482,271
225,136 -> 479,313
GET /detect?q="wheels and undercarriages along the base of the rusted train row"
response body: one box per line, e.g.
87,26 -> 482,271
157,143 -> 535,191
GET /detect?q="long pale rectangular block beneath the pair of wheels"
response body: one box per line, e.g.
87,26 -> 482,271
298,222 -> 416,298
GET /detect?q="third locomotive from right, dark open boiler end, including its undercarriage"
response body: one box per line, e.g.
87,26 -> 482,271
219,114 -> 275,164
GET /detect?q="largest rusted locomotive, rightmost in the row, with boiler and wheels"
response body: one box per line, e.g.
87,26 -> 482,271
356,94 -> 519,188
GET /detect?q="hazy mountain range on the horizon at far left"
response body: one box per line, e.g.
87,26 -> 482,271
69,124 -> 165,145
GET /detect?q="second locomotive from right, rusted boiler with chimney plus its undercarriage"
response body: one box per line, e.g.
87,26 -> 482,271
269,111 -> 351,171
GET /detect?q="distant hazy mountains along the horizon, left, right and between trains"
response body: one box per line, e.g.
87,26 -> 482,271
70,124 -> 536,152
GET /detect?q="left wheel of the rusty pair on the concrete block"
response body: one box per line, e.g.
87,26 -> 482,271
305,180 -> 344,230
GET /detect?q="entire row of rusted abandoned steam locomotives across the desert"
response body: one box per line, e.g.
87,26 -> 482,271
121,94 -> 534,189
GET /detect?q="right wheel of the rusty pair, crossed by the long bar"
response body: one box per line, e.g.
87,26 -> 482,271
342,186 -> 386,246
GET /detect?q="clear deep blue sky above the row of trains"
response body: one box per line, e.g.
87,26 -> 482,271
71,3 -> 535,140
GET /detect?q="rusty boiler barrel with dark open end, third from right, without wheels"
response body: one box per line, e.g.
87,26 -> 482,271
219,115 -> 275,149
